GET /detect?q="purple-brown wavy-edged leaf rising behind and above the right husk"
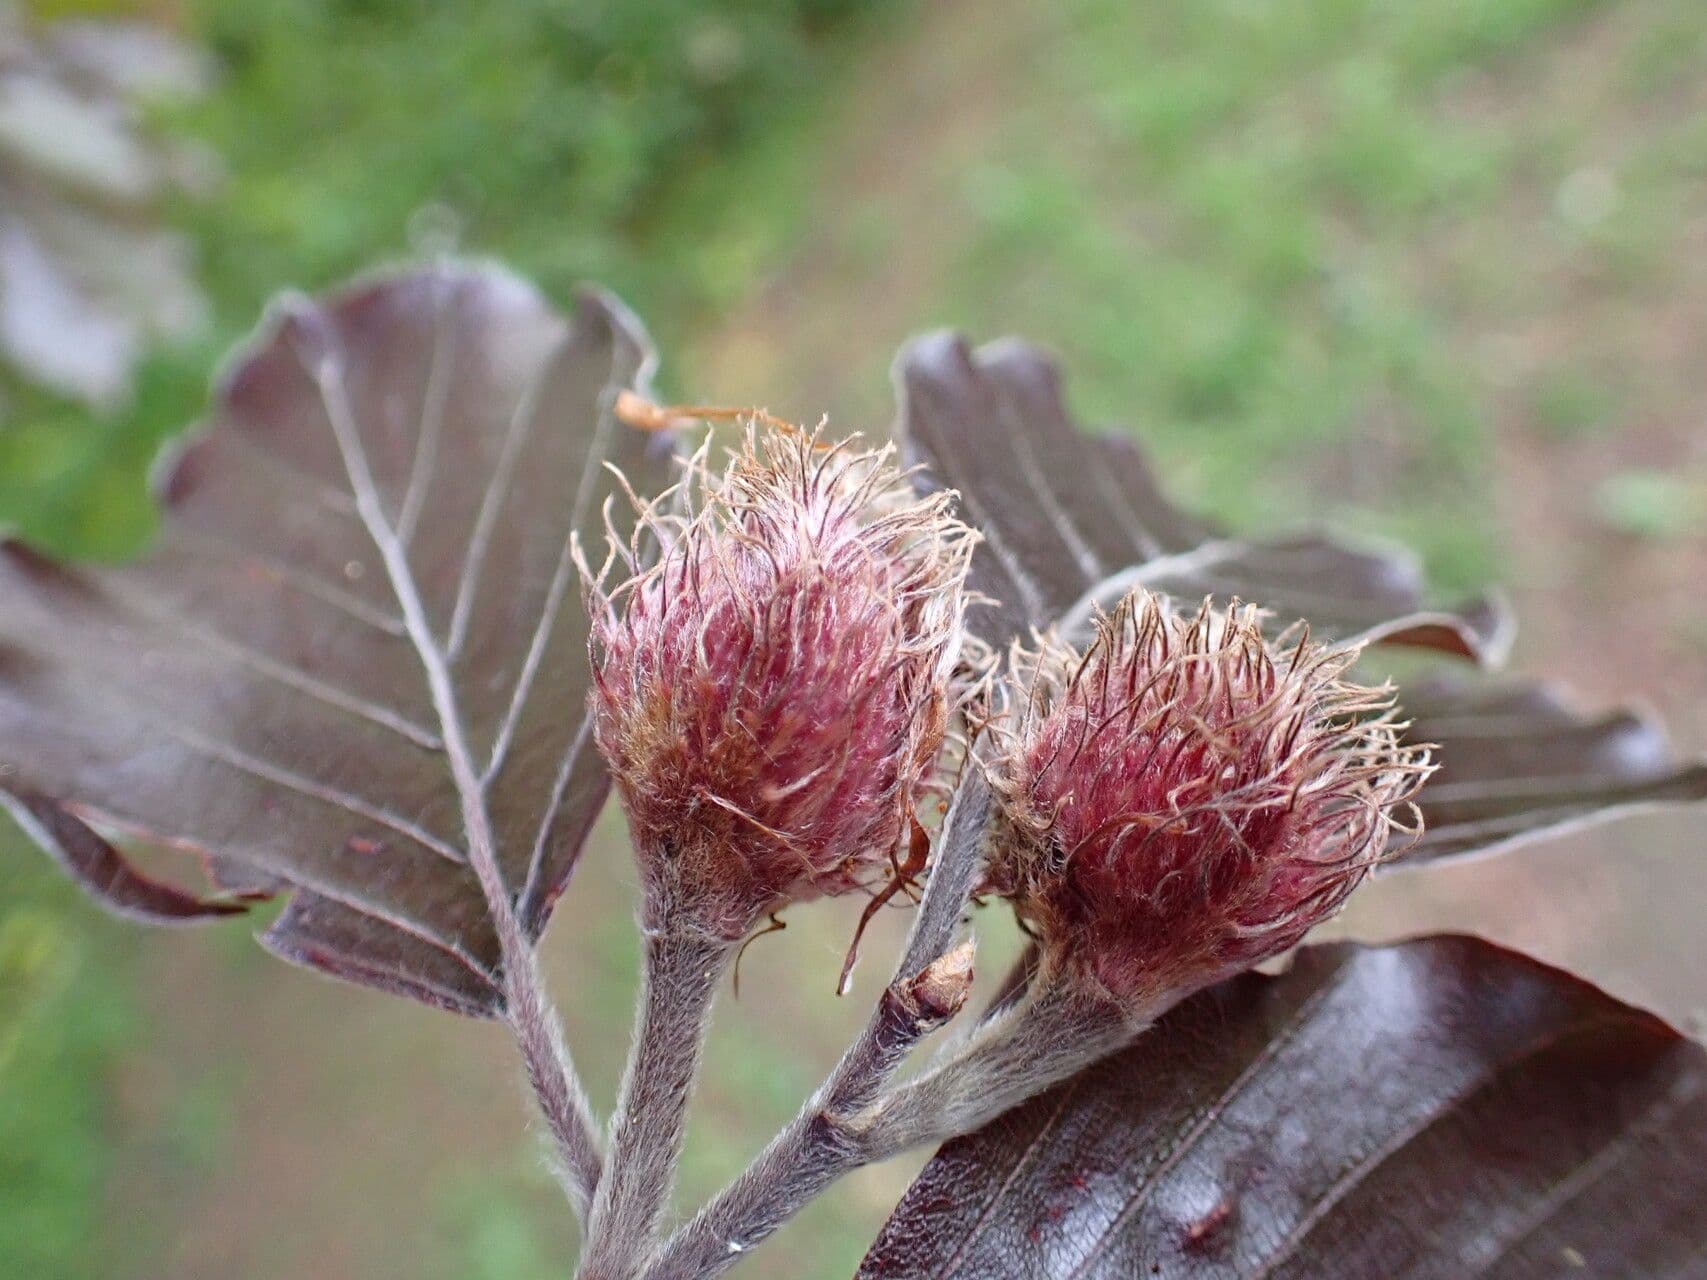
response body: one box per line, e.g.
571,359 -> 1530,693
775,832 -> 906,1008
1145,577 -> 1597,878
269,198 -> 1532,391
896,333 -> 1511,664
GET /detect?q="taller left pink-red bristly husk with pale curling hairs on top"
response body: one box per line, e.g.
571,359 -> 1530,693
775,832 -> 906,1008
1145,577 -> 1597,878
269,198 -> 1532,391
589,428 -> 971,939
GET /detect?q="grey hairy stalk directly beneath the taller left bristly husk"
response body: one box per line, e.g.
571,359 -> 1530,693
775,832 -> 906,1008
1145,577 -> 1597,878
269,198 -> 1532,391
579,913 -> 734,1280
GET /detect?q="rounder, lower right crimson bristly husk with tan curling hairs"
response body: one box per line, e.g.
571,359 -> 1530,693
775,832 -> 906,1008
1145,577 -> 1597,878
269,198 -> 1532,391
988,591 -> 1429,1010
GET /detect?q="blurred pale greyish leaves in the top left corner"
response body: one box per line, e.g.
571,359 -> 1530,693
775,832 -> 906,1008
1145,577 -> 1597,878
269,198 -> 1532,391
0,3 -> 207,411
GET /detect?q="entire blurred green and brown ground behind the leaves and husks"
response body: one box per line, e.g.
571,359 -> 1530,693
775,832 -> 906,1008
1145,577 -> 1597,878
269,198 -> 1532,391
0,0 -> 1707,1280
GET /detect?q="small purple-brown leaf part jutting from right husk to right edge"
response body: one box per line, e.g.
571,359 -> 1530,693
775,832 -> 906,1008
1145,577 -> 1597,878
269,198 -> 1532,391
1395,679 -> 1707,867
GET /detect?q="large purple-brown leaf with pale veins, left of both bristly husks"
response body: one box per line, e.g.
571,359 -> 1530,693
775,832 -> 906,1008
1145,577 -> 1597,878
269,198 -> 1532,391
0,265 -> 673,1014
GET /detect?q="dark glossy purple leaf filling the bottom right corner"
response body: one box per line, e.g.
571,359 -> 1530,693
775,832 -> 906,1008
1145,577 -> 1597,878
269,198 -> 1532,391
859,937 -> 1707,1280
